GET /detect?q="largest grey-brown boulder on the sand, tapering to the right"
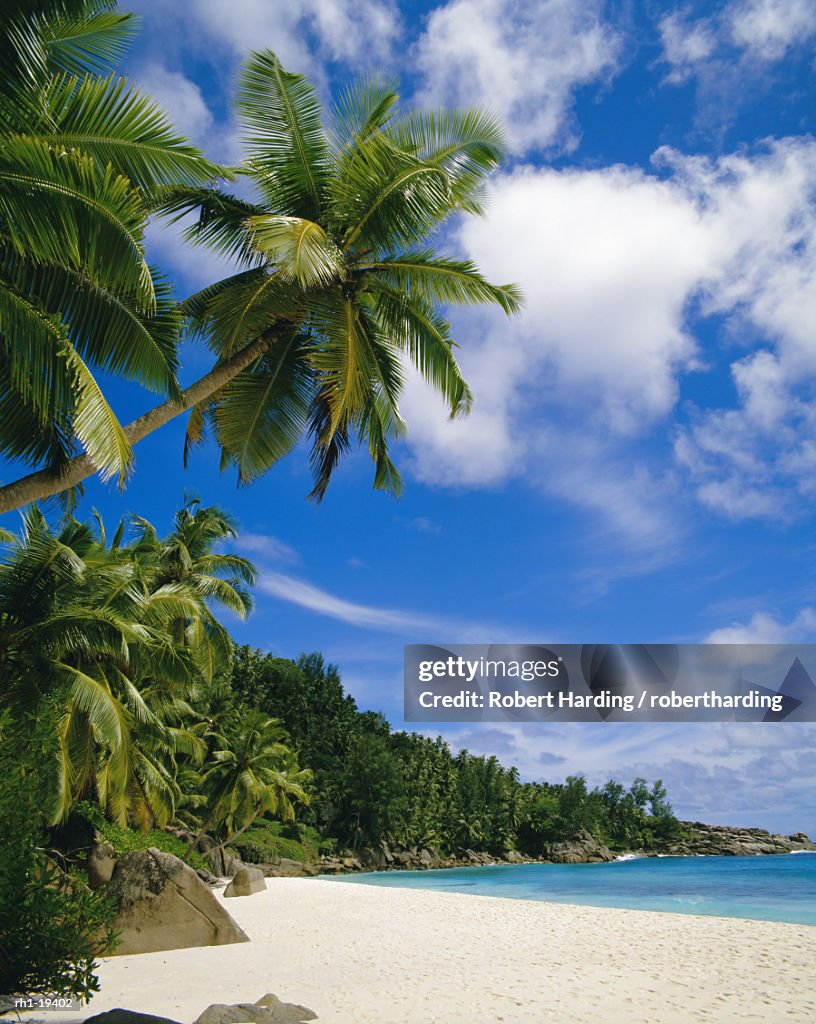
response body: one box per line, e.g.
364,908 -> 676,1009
106,847 -> 249,955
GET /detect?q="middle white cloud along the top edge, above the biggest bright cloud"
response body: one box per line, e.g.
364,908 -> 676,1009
417,0 -> 620,153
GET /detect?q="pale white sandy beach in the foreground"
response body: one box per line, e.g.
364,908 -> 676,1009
41,879 -> 816,1024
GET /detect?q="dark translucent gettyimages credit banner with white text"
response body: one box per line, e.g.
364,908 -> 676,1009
404,644 -> 816,722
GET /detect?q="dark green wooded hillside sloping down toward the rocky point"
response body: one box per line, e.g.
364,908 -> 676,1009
226,647 -> 678,856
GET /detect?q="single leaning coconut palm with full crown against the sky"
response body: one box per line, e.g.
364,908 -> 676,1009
0,51 -> 520,512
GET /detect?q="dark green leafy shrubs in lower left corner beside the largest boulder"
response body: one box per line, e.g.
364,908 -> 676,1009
0,713 -> 114,999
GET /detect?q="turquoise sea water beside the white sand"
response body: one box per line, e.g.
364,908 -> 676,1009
323,853 -> 816,926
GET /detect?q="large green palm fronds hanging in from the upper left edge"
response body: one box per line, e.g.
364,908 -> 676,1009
0,0 -> 224,490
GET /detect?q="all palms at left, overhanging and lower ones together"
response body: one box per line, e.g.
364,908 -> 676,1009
0,0 -> 520,831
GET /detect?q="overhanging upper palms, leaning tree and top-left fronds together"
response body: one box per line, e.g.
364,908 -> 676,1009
0,0 -> 520,513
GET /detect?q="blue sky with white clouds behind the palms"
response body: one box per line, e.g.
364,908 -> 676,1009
3,0 -> 816,831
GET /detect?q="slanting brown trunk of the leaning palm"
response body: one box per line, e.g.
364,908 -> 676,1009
0,332 -> 277,515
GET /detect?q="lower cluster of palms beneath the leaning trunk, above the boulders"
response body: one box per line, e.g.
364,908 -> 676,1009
0,501 -> 309,834
